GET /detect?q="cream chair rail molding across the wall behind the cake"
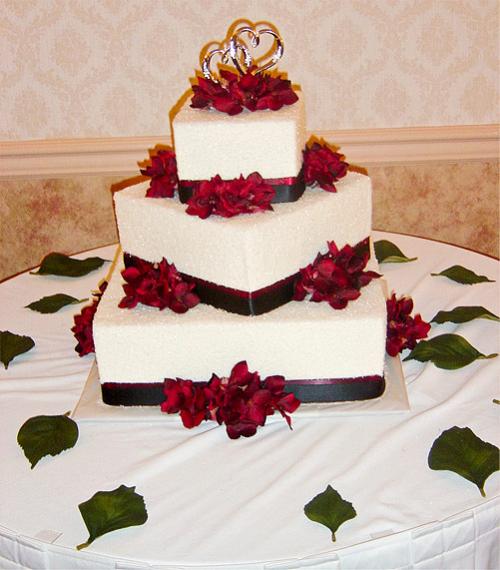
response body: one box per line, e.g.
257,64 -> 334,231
0,124 -> 499,179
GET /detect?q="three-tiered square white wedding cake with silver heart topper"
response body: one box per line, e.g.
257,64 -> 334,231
93,23 -> 386,405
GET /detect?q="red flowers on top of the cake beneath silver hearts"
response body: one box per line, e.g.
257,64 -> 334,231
191,69 -> 298,115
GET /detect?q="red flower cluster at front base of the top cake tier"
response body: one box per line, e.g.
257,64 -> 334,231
186,172 -> 275,219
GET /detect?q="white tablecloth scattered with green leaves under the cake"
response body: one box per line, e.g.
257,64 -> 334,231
0,233 -> 500,569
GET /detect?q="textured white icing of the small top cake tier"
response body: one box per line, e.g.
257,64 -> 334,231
172,93 -> 306,180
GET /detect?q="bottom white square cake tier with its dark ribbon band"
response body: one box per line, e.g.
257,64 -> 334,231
93,255 -> 386,405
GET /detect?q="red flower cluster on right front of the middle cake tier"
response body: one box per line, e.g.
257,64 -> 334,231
293,238 -> 380,309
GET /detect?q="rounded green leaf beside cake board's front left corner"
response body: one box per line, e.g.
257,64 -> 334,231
17,412 -> 78,469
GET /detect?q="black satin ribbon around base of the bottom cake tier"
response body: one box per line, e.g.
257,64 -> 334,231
101,376 -> 385,406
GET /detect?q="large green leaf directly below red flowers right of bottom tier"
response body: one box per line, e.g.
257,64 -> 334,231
404,334 -> 498,370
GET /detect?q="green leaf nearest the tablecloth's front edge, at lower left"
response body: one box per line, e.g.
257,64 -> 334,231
77,485 -> 148,550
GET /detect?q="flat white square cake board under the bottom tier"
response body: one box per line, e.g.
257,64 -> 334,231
71,355 -> 410,423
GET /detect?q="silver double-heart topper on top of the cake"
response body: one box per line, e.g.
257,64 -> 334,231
201,26 -> 284,83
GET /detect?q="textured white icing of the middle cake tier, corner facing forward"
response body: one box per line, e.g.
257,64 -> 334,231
115,172 -> 371,291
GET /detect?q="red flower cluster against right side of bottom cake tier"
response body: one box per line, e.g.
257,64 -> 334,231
386,293 -> 431,356
